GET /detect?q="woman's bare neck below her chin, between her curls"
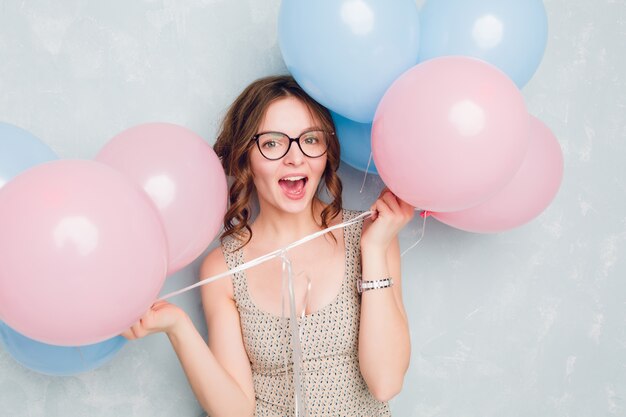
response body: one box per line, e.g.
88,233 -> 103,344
252,199 -> 324,248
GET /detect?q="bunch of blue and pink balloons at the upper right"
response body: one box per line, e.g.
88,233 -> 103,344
279,0 -> 563,232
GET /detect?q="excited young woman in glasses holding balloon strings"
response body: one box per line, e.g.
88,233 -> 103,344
125,76 -> 414,417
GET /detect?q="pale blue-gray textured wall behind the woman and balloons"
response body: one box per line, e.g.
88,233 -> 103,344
0,0 -> 626,417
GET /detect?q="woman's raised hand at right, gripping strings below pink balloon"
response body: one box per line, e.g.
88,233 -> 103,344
361,188 -> 415,251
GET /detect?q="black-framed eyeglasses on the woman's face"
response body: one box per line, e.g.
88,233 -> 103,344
252,130 -> 335,161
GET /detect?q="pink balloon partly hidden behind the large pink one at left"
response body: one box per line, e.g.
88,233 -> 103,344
96,123 -> 227,274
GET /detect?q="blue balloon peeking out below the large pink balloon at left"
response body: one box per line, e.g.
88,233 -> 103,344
0,322 -> 126,376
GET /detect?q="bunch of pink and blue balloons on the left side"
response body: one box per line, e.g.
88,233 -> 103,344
0,123 -> 227,375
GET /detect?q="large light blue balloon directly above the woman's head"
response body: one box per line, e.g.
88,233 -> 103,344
278,0 -> 419,123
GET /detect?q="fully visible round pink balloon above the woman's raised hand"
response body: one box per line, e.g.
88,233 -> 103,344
372,57 -> 529,212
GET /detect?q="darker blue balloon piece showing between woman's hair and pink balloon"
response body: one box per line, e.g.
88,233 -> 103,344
331,112 -> 378,175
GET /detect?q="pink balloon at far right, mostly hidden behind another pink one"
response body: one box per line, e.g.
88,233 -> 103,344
431,116 -> 563,233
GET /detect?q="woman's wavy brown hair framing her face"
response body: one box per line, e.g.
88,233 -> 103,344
213,75 -> 342,248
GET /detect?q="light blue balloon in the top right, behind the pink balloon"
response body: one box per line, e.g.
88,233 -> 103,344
419,0 -> 548,88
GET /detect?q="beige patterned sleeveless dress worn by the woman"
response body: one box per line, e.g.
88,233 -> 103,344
217,210 -> 391,417
